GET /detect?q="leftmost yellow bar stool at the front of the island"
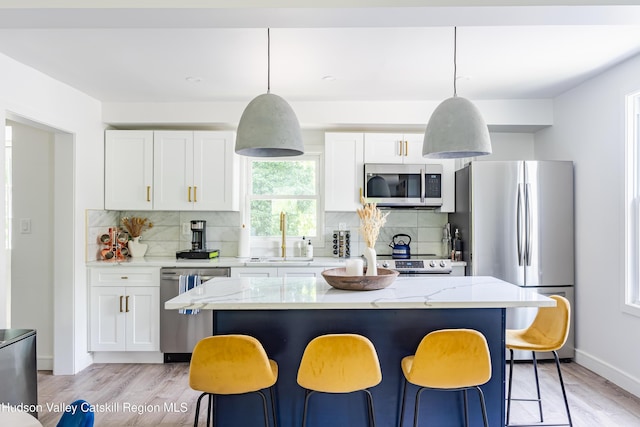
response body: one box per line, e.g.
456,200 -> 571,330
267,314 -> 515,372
189,335 -> 278,427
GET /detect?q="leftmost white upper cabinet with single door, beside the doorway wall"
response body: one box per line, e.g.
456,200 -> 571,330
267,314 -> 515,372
104,130 -> 153,211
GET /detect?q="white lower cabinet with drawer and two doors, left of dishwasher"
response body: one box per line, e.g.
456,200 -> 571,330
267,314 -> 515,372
89,267 -> 160,351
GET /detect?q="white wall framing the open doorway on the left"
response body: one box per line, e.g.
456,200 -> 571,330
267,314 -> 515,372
0,55 -> 104,374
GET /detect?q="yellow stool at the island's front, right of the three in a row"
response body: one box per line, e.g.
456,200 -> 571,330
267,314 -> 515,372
399,329 -> 491,427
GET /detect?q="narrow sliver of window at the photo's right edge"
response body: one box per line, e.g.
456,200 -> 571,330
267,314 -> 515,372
623,92 -> 640,315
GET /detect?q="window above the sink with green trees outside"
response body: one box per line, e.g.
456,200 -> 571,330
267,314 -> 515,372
247,155 -> 321,244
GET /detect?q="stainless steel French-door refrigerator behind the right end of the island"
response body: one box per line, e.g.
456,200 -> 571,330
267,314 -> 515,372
449,161 -> 575,359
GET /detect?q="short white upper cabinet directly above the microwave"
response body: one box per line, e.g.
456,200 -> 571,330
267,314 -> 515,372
364,133 -> 427,164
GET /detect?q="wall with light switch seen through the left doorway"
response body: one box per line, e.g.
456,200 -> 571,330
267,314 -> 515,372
9,122 -> 54,370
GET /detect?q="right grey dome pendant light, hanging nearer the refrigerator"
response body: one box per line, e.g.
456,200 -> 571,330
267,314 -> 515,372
422,27 -> 491,159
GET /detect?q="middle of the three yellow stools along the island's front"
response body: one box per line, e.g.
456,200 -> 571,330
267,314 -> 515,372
298,334 -> 382,427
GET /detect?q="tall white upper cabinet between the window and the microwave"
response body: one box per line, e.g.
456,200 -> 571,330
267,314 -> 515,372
324,132 -> 364,211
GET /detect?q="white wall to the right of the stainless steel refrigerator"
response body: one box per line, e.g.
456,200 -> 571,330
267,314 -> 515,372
535,56 -> 640,396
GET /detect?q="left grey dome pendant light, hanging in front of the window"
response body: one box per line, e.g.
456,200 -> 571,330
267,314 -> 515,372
236,28 -> 304,157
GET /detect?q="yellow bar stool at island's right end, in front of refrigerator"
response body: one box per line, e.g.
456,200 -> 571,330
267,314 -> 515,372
505,295 -> 573,426
